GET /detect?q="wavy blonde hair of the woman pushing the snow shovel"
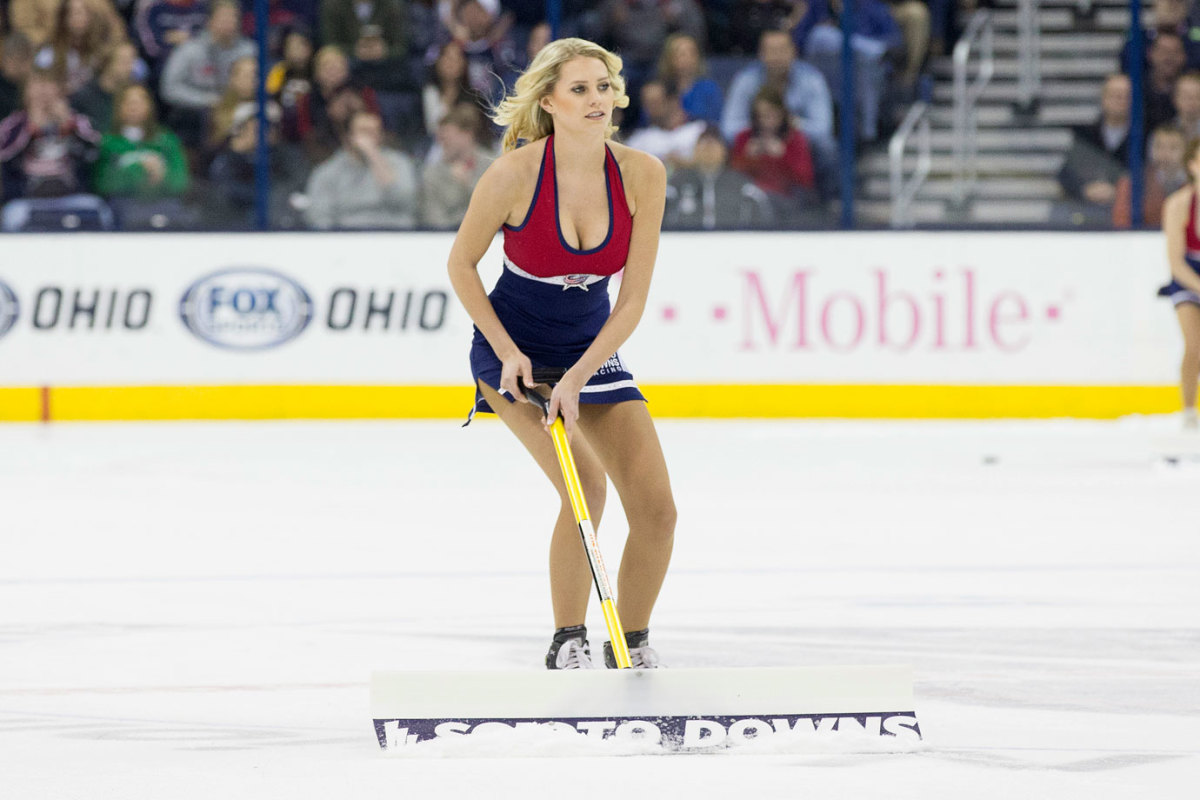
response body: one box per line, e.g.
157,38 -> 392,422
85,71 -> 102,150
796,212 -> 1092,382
491,38 -> 629,152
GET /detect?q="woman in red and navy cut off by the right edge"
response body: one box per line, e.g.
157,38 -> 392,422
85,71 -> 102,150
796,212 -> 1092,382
1158,139 -> 1200,431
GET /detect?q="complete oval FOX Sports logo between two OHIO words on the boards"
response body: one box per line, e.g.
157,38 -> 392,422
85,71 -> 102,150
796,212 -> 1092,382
179,267 -> 312,350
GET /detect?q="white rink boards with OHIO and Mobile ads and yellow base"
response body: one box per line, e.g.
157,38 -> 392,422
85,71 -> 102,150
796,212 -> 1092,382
0,233 -> 1182,421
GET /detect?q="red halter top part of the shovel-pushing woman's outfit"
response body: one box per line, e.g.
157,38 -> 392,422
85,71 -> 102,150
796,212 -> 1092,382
504,134 -> 634,278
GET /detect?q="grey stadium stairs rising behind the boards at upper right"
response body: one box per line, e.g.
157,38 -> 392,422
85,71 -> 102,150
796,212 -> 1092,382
856,0 -> 1128,227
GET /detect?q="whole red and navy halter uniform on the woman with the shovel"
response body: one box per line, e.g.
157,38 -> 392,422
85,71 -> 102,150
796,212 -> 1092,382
470,136 -> 646,411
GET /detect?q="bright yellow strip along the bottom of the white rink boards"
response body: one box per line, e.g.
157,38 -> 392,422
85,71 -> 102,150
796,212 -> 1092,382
0,384 -> 1180,422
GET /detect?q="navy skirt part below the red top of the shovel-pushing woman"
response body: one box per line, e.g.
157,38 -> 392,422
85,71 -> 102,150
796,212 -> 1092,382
470,266 -> 646,416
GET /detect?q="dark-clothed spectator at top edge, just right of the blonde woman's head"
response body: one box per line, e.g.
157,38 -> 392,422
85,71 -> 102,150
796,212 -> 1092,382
596,0 -> 708,120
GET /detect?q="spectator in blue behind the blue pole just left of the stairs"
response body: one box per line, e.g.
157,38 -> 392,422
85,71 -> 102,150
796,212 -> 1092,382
793,0 -> 904,142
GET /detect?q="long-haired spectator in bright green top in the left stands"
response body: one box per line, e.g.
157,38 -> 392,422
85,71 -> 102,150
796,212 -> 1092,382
95,84 -> 188,200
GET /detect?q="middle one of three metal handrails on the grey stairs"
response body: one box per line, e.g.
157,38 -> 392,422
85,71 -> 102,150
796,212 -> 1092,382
954,10 -> 996,203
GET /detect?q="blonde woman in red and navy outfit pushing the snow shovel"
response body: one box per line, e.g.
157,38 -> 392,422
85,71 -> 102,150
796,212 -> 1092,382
449,38 -> 676,669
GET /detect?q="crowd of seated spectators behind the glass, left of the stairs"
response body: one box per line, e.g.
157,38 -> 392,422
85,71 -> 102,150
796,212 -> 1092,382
0,0 -> 974,230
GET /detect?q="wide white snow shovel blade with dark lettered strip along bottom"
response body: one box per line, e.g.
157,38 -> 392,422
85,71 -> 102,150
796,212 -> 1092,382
371,666 -> 920,751
